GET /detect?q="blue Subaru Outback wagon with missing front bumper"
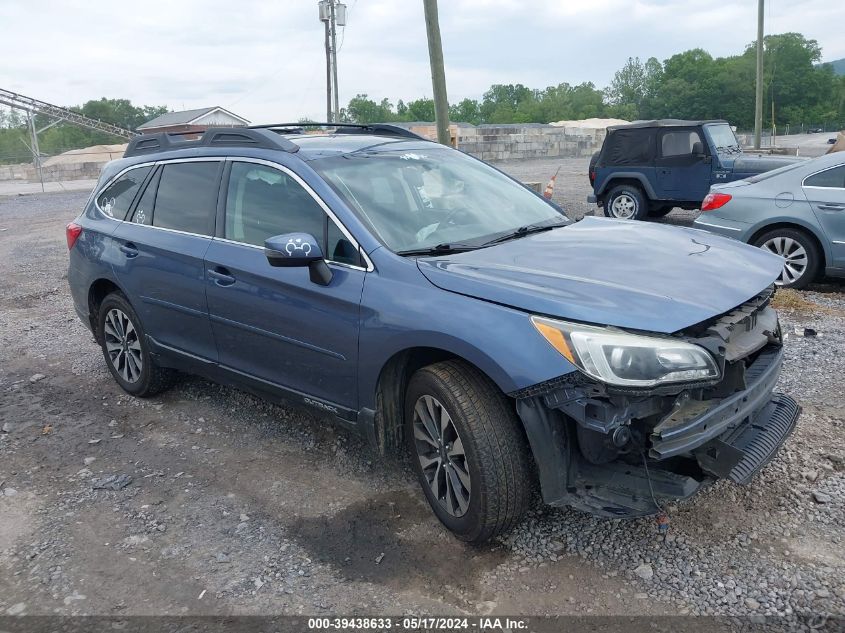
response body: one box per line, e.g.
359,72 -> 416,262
67,125 -> 799,542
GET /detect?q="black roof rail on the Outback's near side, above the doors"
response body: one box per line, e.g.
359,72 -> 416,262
123,127 -> 299,158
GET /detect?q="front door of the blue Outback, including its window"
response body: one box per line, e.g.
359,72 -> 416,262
205,161 -> 366,417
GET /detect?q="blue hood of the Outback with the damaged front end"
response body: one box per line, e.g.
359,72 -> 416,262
417,218 -> 782,333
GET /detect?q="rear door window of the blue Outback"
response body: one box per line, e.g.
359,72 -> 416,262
152,161 -> 220,235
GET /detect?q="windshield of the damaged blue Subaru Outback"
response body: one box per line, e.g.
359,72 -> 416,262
312,147 -> 569,253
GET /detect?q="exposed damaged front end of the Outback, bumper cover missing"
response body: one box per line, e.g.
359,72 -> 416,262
511,287 -> 800,517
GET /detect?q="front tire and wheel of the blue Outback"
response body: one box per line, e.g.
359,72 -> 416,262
405,360 -> 533,543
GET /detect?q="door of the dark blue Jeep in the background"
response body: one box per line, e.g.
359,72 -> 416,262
655,128 -> 712,201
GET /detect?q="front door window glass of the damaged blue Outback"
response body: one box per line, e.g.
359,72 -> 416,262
226,162 -> 324,248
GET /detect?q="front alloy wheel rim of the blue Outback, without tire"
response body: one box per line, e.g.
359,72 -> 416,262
413,395 -> 472,517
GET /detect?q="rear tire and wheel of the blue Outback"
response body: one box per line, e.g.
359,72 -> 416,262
97,292 -> 174,398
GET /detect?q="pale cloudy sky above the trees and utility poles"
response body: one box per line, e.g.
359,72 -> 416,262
0,0 -> 845,123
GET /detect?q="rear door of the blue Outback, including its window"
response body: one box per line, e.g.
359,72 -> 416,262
113,159 -> 224,362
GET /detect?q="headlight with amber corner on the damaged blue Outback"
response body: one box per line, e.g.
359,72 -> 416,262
531,316 -> 719,387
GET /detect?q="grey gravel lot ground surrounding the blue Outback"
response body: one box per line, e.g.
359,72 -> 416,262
0,160 -> 845,624
